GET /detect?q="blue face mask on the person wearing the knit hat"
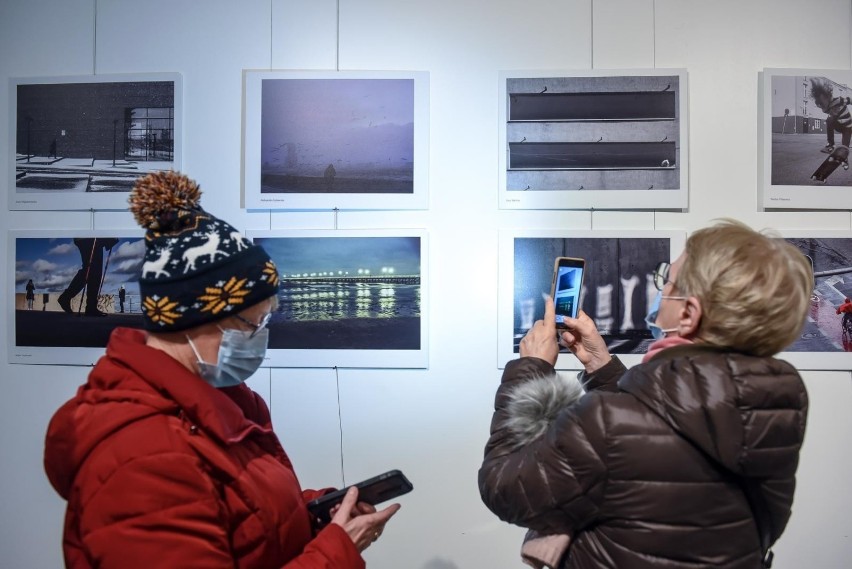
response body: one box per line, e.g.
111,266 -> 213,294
186,328 -> 269,388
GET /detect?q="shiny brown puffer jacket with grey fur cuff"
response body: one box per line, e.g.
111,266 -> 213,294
479,346 -> 808,569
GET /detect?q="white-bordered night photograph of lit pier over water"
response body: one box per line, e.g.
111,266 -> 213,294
248,229 -> 428,368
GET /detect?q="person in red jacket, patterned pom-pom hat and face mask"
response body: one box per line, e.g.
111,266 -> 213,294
45,172 -> 399,569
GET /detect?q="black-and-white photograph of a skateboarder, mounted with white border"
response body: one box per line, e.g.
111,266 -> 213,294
758,69 -> 852,209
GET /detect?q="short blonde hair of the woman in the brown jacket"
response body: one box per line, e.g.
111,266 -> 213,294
675,219 -> 814,356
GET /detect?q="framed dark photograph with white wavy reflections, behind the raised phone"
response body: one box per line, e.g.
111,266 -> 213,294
497,230 -> 686,369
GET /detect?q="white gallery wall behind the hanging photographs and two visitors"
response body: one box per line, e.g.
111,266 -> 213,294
0,0 -> 852,569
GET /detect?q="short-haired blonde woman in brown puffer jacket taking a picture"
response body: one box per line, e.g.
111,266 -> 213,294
479,222 -> 813,569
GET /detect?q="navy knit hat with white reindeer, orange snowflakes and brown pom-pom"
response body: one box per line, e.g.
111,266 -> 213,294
128,171 -> 279,332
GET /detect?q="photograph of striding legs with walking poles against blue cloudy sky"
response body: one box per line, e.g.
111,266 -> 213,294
7,231 -> 145,365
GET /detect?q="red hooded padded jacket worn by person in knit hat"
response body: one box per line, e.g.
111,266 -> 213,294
44,328 -> 365,569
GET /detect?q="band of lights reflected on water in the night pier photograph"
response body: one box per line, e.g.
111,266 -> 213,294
278,281 -> 420,322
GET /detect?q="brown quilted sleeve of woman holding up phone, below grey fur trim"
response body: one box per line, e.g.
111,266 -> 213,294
479,357 -> 607,533
